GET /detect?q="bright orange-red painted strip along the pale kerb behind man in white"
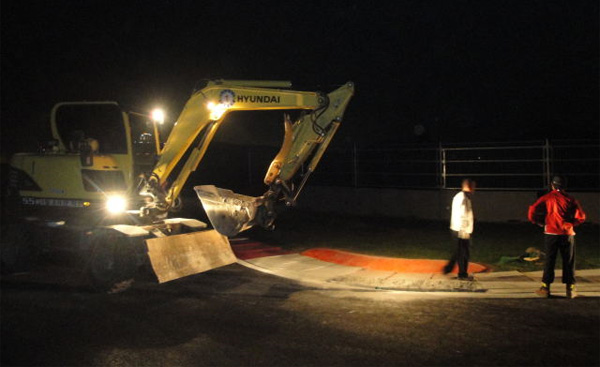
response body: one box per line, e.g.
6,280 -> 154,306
301,248 -> 488,273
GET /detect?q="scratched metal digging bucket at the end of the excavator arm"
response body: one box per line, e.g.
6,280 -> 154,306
194,185 -> 260,237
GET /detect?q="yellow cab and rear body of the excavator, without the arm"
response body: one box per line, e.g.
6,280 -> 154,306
9,102 -> 135,225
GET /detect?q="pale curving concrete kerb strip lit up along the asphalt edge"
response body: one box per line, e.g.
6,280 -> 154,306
237,254 -> 600,298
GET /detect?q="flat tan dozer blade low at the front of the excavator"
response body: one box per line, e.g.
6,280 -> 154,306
146,230 -> 236,283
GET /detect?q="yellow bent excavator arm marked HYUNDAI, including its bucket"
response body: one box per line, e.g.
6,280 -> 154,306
140,80 -> 354,236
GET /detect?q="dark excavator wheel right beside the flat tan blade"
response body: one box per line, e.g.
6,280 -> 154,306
88,229 -> 138,293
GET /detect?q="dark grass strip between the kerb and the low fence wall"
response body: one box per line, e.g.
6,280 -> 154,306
248,209 -> 600,271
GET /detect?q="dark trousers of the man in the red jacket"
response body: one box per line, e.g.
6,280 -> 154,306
542,234 -> 575,286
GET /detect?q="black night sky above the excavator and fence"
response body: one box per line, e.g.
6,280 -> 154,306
1,0 -> 599,158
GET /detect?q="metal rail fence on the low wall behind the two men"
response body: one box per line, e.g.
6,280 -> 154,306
311,140 -> 600,191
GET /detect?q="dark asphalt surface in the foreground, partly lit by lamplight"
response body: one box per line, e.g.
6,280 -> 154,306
0,264 -> 600,366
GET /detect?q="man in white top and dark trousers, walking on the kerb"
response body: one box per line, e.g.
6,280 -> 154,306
444,178 -> 475,280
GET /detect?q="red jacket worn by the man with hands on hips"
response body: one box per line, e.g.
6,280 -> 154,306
527,190 -> 585,236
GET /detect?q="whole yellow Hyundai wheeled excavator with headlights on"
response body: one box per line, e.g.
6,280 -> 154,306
2,79 -> 354,290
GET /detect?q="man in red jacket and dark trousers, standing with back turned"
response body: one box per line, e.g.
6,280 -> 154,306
527,176 -> 585,298
